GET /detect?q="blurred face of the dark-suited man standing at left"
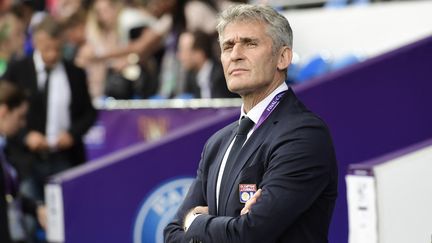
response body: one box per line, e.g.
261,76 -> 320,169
34,31 -> 62,68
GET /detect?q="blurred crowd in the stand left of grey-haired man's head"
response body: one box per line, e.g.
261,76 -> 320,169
0,0 -> 247,101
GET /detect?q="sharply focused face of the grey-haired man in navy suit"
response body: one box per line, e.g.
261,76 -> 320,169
220,22 -> 286,96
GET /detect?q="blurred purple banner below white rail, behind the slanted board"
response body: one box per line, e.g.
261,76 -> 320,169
86,108 -> 238,160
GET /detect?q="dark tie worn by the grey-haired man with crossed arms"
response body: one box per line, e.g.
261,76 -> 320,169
219,116 -> 255,201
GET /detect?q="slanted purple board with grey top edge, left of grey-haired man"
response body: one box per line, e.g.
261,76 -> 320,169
51,108 -> 240,243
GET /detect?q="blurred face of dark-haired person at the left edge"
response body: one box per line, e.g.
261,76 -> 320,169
2,102 -> 28,136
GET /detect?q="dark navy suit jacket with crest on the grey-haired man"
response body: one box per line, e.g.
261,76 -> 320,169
164,90 -> 337,243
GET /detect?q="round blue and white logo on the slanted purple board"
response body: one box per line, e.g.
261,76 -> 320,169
133,178 -> 193,243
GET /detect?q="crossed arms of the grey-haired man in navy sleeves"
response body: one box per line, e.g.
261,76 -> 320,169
165,124 -> 335,243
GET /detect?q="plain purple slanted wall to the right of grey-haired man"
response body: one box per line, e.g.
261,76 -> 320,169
297,37 -> 432,243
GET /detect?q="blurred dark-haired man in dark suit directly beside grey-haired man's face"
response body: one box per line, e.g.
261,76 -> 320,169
177,31 -> 237,98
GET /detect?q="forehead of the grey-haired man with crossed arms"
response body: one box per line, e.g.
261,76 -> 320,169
220,21 -> 269,44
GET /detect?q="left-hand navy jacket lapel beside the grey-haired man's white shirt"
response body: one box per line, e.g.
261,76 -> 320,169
207,125 -> 238,215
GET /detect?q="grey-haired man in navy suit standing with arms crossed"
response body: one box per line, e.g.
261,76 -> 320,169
164,5 -> 337,243
